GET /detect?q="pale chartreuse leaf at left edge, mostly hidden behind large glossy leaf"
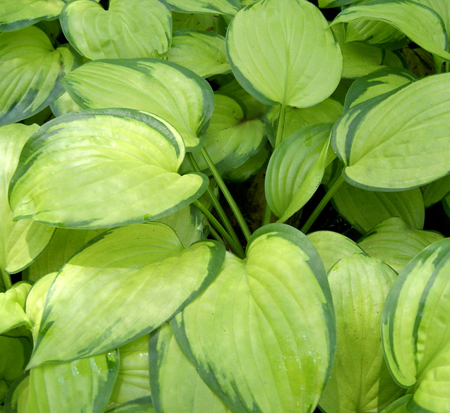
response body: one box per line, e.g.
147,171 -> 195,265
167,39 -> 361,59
0,124 -> 55,273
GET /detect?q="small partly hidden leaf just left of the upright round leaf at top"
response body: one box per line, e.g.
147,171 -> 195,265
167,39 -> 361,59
167,30 -> 231,77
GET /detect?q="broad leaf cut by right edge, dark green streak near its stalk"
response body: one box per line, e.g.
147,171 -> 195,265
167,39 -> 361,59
332,73 -> 450,191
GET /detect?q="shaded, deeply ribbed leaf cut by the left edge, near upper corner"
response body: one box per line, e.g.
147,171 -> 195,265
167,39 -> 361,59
0,26 -> 76,125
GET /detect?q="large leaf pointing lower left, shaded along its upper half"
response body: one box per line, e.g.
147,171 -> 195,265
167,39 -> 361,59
29,223 -> 225,367
